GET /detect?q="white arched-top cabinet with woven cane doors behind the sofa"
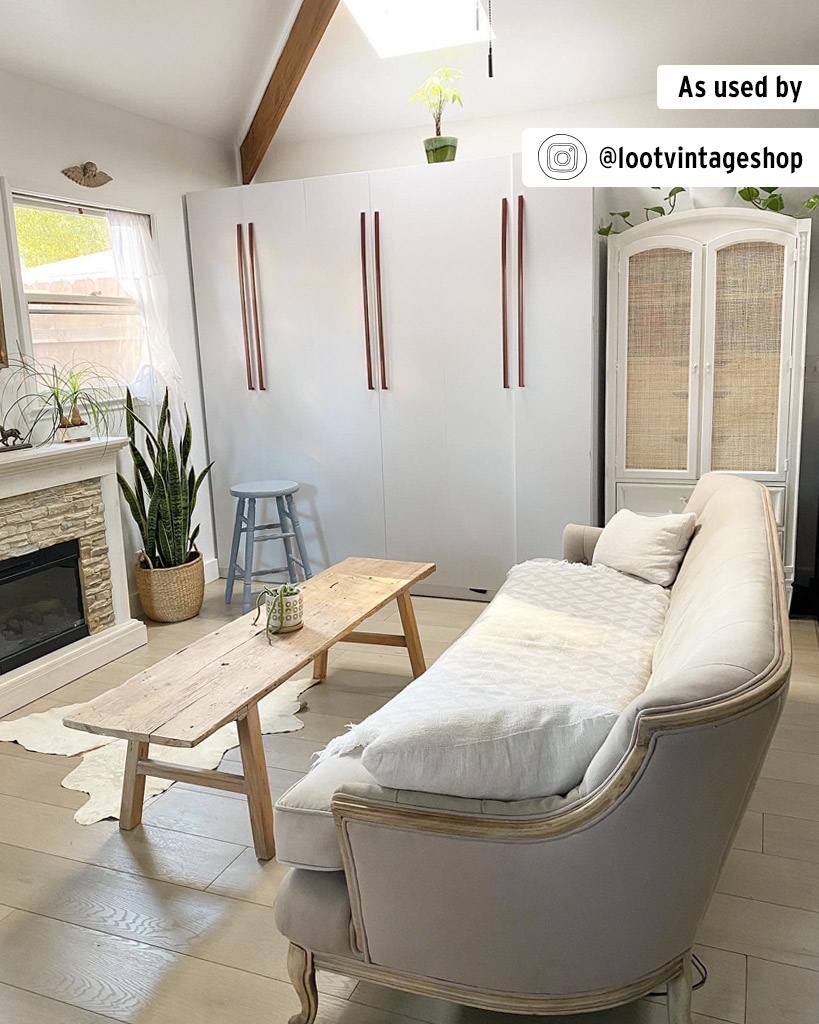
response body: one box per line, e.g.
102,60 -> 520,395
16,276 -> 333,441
606,209 -> 811,583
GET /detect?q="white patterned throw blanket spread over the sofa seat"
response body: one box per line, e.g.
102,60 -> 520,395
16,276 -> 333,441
316,559 -> 669,763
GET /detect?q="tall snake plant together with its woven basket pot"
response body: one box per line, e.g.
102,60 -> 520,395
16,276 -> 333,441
118,389 -> 213,623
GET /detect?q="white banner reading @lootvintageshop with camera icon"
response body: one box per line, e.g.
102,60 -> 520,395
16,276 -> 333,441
523,125 -> 819,191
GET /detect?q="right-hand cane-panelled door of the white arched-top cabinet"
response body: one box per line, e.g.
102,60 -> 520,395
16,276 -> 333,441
702,228 -> 795,479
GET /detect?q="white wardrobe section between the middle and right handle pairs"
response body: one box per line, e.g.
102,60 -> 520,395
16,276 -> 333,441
371,158 -> 515,593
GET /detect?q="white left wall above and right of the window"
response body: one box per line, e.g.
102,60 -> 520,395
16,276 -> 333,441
0,72 -> 236,585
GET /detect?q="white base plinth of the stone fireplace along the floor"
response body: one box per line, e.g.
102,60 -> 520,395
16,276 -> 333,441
0,618 -> 147,717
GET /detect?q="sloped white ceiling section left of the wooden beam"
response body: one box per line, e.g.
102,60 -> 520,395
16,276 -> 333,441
0,0 -> 298,142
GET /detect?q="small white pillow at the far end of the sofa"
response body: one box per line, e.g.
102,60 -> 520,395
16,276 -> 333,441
592,509 -> 697,587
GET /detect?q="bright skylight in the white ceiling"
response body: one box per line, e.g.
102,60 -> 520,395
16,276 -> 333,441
345,0 -> 489,57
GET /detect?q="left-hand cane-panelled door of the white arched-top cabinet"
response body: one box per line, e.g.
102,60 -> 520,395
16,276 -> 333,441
614,236 -> 702,480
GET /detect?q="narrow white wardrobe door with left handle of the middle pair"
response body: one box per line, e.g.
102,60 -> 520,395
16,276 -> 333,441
304,174 -> 386,565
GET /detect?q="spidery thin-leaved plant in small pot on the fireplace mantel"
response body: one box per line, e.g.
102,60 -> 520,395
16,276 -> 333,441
0,356 -> 121,444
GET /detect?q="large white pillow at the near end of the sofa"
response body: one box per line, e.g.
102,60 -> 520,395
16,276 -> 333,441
361,700 -> 618,800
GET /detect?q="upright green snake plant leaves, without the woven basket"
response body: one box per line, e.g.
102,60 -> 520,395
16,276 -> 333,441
117,388 -> 213,569
